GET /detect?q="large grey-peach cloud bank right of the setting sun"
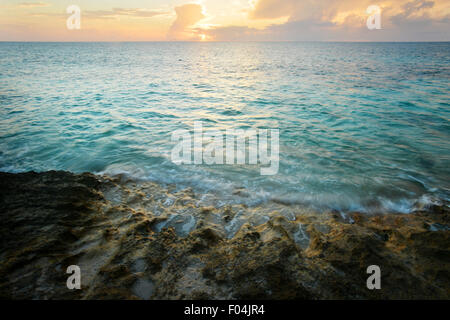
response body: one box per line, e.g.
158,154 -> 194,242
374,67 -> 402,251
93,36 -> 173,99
197,0 -> 450,41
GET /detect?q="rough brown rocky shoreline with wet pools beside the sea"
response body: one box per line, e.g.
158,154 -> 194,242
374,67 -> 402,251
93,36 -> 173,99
0,171 -> 450,299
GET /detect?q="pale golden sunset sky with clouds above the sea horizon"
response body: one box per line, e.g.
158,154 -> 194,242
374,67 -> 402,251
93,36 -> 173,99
0,0 -> 450,41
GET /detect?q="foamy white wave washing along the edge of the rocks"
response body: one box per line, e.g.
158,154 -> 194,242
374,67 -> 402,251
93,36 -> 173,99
96,165 -> 448,214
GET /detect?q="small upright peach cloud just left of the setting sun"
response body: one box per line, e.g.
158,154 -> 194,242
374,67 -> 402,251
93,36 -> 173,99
167,3 -> 206,40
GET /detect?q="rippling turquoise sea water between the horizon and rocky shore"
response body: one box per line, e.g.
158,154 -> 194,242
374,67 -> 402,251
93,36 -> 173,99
0,43 -> 450,212
